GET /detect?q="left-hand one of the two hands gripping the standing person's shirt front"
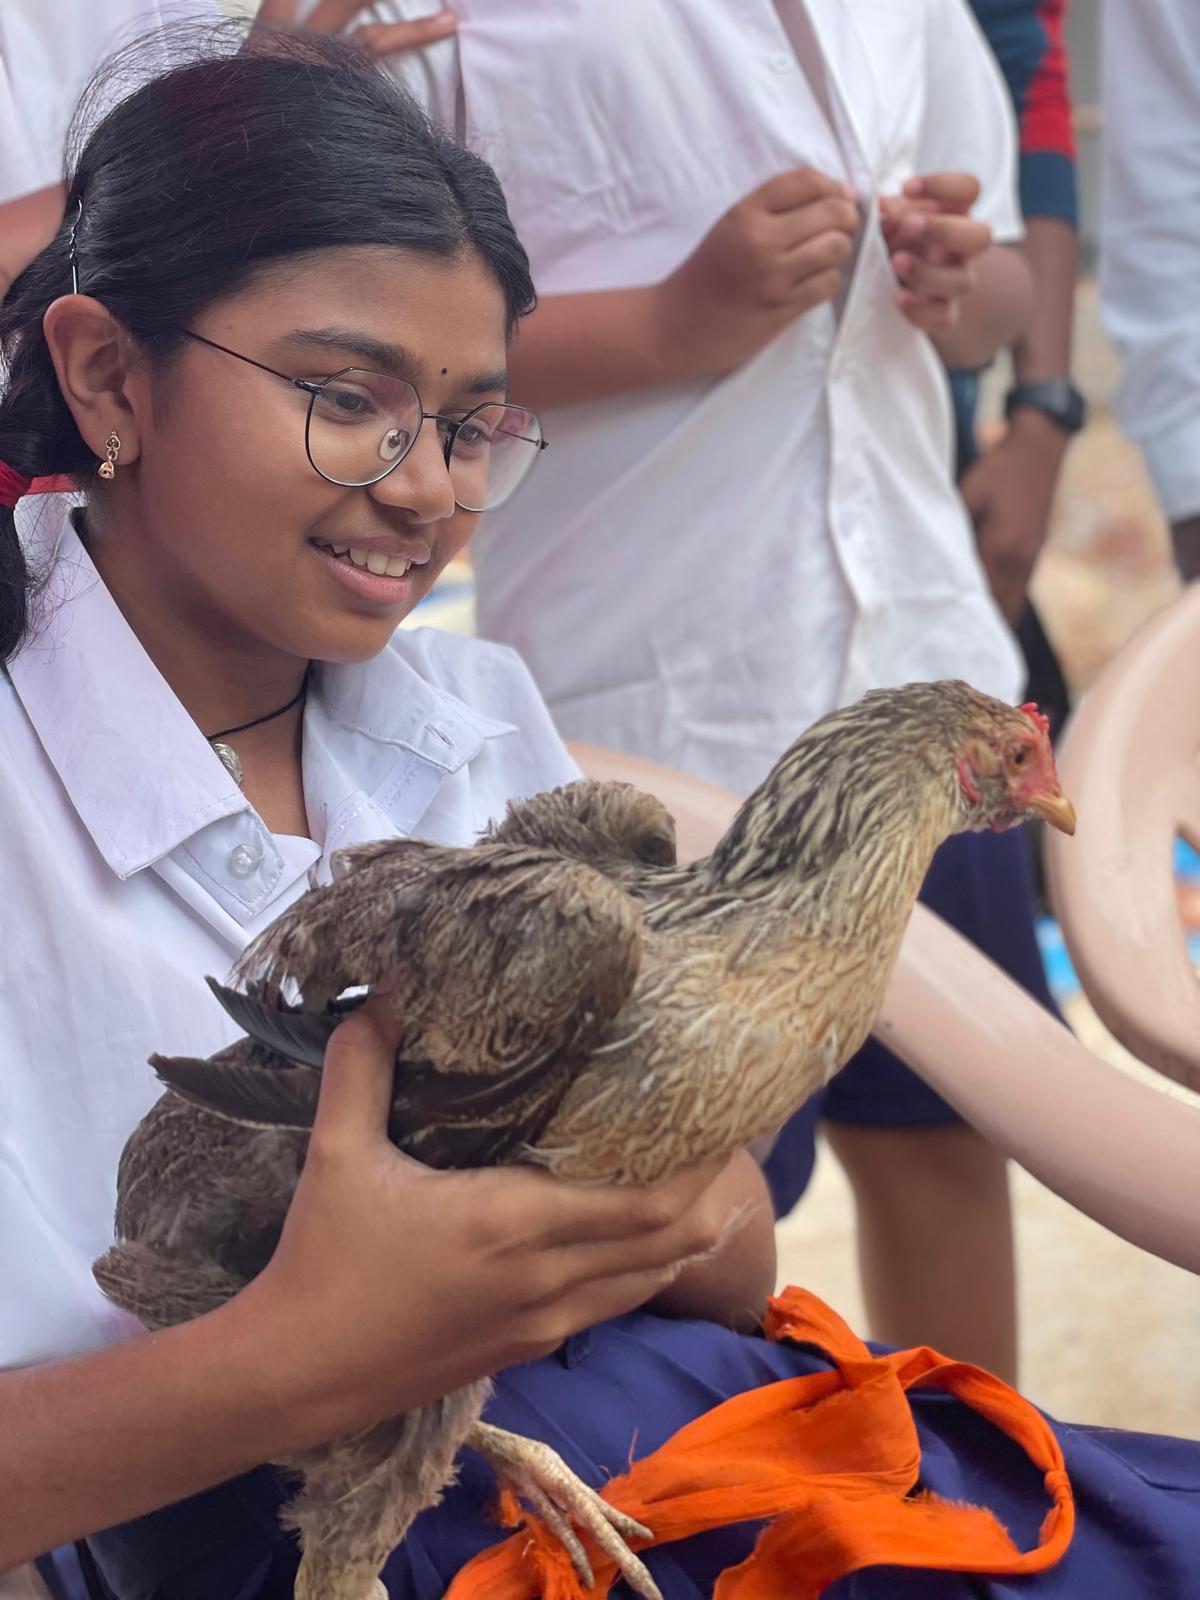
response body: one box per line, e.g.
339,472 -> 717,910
659,166 -> 859,374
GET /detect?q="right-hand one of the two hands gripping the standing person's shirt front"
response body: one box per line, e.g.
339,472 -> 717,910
880,173 -> 992,334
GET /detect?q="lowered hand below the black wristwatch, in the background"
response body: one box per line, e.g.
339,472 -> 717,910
960,408 -> 1069,624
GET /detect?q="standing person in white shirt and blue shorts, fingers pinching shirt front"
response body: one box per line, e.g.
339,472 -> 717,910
371,0 -> 1050,1373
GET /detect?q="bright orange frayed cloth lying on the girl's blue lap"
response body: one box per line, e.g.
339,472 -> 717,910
446,1288 -> 1075,1600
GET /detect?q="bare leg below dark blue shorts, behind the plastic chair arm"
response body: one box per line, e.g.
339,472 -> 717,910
822,1122 -> 1016,1384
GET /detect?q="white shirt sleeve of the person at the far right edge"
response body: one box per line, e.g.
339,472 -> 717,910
1099,0 -> 1200,581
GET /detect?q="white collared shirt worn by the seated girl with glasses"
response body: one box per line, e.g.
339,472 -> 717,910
0,501 -> 576,1366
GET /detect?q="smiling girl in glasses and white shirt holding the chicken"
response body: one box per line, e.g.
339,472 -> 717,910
0,21 -> 1197,1600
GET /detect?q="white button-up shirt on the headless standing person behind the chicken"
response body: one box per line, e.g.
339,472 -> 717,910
360,0 -> 1022,790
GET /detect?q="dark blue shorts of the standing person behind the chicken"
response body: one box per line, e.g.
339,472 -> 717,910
765,829 -> 1058,1216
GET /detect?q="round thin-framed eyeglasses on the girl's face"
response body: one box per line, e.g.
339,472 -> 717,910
182,328 -> 547,512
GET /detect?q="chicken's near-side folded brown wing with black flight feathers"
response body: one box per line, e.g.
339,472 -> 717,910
160,832 -> 653,1166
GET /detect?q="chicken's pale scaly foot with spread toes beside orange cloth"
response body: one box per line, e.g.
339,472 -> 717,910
467,1422 -> 662,1600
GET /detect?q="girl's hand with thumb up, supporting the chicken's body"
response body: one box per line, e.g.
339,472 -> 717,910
237,1000 -> 739,1443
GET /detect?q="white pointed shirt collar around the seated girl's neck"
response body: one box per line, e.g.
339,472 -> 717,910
8,496 -> 515,878
